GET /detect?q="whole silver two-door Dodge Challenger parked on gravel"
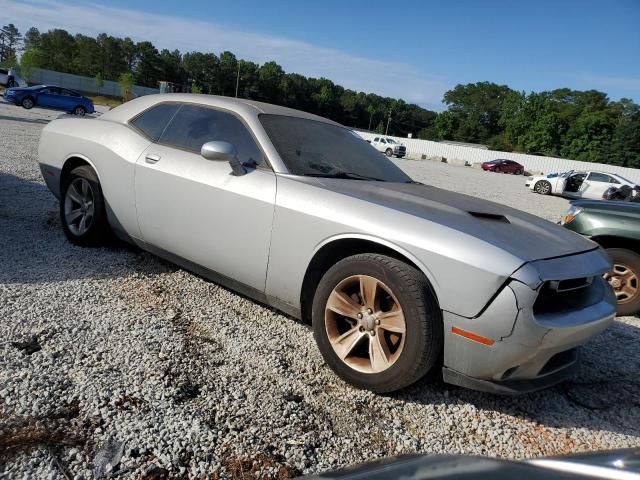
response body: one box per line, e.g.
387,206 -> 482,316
39,94 -> 616,393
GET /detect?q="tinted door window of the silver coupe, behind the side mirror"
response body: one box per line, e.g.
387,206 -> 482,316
160,105 -> 264,164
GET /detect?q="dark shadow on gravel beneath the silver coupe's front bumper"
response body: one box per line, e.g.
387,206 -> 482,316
392,317 -> 640,437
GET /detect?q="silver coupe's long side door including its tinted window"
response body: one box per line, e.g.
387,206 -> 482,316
135,104 -> 276,292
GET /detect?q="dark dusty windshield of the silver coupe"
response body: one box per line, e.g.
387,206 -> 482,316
260,115 -> 411,182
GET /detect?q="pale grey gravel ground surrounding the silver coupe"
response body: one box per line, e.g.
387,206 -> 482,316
0,104 -> 640,478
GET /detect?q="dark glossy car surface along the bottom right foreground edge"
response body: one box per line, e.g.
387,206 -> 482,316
304,448 -> 640,480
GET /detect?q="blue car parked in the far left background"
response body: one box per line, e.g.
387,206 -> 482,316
4,85 -> 94,115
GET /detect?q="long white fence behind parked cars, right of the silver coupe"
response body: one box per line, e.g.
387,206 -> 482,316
356,131 -> 640,184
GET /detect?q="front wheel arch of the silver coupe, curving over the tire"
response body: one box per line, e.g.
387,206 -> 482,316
300,234 -> 439,324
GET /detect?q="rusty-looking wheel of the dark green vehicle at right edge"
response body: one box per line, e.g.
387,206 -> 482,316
605,248 -> 640,316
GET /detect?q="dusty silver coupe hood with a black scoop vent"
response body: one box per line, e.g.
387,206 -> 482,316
303,178 -> 598,262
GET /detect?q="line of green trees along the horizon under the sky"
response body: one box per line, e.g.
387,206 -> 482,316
0,24 -> 640,168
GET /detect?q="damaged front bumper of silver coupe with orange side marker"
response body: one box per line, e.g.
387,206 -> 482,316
443,248 -> 616,394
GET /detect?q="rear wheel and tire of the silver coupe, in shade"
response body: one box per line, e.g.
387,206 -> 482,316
60,165 -> 110,247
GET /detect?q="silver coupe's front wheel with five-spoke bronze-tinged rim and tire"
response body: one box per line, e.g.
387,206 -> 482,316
312,253 -> 443,393
